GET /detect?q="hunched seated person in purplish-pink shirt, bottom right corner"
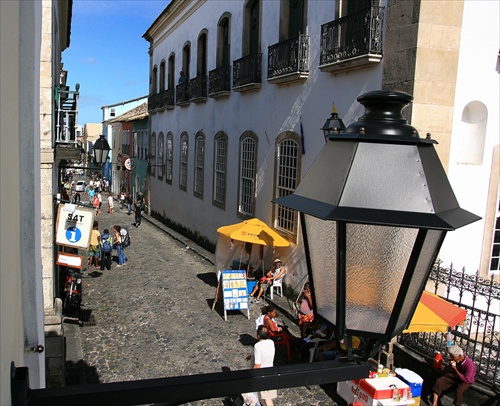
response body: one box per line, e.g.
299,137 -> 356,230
432,345 -> 476,406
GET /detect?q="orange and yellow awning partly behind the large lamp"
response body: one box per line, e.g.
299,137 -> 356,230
403,291 -> 467,333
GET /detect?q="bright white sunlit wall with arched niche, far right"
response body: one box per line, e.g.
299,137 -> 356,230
440,0 -> 500,274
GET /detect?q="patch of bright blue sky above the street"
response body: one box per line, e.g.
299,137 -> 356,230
62,0 -> 169,125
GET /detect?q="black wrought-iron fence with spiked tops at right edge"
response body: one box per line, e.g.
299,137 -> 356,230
398,261 -> 500,388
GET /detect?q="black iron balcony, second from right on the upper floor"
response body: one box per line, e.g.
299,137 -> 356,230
267,34 -> 309,83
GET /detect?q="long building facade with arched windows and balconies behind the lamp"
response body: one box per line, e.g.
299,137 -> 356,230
144,0 -> 498,287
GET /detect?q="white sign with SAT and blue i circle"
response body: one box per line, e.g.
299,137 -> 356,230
56,204 -> 95,249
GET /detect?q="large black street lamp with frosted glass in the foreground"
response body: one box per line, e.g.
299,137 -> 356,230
273,91 -> 479,356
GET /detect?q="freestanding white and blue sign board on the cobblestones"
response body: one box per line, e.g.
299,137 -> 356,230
219,270 -> 250,321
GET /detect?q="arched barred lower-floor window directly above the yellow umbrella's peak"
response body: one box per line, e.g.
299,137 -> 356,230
238,133 -> 257,216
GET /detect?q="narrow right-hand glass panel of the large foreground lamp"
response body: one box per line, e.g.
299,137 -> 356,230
392,230 -> 446,337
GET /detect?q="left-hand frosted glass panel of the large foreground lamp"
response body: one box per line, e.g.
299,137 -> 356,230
302,214 -> 337,324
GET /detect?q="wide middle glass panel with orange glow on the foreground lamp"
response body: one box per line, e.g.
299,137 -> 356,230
346,223 -> 418,334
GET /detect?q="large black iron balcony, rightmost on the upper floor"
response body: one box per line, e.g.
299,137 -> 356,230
319,6 -> 384,72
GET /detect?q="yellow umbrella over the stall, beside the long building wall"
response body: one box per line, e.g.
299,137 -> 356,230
217,218 -> 290,247
